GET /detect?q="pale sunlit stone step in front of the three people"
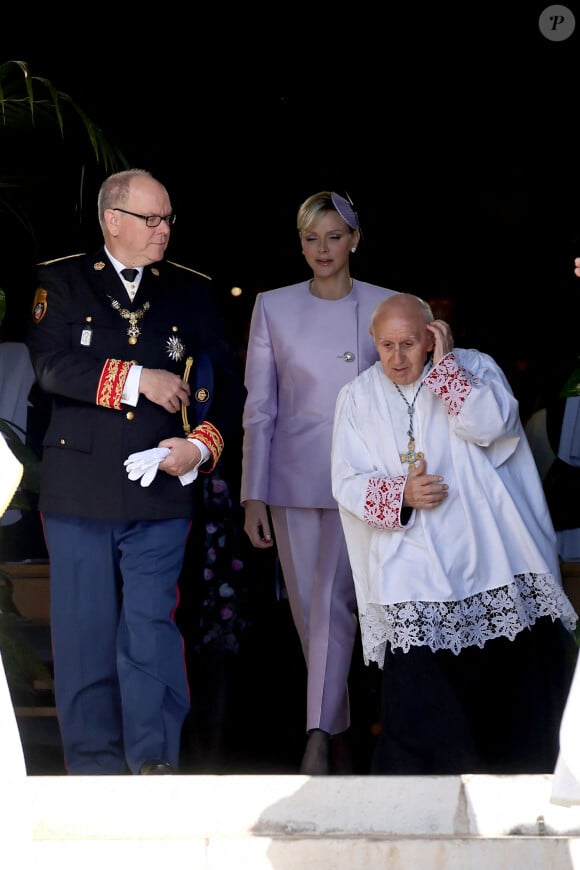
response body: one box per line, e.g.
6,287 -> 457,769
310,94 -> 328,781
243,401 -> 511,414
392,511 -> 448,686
15,774 -> 580,870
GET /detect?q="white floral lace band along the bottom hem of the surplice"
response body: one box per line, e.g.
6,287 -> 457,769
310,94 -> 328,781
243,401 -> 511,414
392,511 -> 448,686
360,574 -> 578,668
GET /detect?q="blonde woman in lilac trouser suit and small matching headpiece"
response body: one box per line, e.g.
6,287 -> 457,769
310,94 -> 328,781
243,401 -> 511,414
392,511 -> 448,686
241,191 -> 395,775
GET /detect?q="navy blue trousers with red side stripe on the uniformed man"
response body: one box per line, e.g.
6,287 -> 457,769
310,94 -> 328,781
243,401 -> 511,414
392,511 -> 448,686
43,514 -> 191,775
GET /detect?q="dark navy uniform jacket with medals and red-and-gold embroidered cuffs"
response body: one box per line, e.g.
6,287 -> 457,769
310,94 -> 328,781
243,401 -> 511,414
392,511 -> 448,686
28,249 -> 244,521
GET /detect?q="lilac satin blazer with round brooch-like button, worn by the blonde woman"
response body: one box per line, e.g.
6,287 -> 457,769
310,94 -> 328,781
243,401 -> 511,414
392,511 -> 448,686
241,280 -> 396,508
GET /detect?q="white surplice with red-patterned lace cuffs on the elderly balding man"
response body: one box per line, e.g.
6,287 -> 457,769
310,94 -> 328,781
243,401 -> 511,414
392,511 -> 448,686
332,348 -> 577,666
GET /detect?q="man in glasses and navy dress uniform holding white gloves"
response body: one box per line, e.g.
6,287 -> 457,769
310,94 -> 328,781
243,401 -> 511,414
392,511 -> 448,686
28,169 -> 243,775
